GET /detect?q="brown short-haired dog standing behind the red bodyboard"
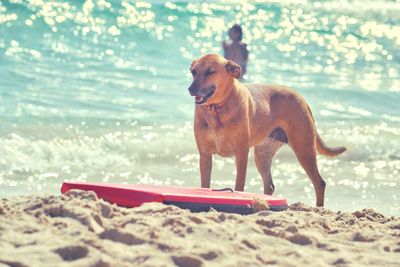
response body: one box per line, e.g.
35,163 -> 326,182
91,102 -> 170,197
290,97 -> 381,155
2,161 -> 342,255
189,54 -> 346,206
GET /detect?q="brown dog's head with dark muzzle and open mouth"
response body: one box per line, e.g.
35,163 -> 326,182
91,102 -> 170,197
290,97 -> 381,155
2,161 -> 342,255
189,54 -> 240,105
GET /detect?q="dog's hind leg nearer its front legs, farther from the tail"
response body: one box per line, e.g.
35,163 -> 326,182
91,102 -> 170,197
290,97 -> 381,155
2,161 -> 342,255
254,131 -> 284,195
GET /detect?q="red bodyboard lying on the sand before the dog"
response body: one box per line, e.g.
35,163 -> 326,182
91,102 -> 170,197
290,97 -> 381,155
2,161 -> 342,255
61,182 -> 287,214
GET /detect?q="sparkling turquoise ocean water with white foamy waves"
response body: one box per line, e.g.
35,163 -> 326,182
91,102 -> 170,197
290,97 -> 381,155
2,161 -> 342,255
0,0 -> 400,216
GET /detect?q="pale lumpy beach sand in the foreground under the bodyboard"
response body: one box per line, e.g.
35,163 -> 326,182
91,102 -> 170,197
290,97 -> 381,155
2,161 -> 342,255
0,190 -> 400,266
